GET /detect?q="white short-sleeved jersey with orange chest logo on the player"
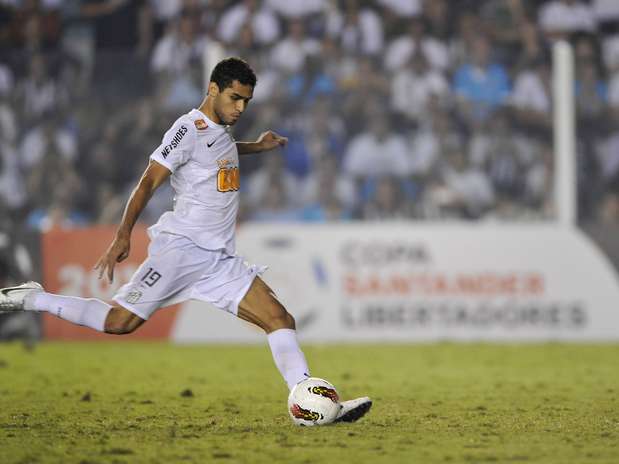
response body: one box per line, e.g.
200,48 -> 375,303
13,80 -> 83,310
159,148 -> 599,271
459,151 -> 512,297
148,109 -> 239,254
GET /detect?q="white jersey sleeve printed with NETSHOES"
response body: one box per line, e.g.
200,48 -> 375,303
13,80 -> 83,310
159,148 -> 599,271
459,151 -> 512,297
150,117 -> 196,172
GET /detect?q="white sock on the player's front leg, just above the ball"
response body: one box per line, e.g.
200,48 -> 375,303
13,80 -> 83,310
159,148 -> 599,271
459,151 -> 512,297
267,329 -> 309,390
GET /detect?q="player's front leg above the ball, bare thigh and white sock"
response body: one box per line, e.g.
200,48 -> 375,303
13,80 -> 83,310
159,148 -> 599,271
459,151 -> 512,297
237,276 -> 309,389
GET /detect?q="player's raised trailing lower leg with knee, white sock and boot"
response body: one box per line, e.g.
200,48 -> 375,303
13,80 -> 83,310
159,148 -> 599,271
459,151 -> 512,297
0,282 -> 144,335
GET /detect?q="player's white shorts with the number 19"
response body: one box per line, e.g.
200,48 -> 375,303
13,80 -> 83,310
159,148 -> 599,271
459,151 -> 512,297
113,233 -> 266,320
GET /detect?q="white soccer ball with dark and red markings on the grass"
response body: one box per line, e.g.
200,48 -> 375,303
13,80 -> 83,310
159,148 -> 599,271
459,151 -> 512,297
288,377 -> 342,426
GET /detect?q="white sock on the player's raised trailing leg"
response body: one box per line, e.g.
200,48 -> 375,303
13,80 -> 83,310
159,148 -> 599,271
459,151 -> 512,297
24,292 -> 112,332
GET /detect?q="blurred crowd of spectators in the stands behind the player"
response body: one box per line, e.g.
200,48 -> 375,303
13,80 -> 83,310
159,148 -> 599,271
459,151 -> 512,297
0,0 -> 619,230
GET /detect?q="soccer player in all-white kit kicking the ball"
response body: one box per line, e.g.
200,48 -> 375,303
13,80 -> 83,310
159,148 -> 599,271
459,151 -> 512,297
0,58 -> 372,422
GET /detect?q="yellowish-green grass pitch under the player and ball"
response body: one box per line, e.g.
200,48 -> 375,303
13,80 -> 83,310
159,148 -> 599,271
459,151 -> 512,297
0,341 -> 619,464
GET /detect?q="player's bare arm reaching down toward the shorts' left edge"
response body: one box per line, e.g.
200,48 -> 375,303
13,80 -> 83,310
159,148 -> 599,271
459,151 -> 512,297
95,160 -> 170,283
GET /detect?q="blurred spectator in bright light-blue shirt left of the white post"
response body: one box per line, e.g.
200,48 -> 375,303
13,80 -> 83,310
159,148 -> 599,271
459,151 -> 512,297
454,36 -> 510,121
